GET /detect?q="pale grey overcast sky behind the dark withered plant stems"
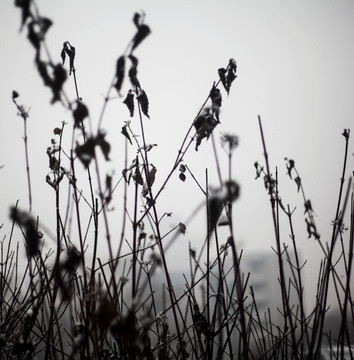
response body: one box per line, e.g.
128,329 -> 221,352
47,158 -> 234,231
0,0 -> 354,304
